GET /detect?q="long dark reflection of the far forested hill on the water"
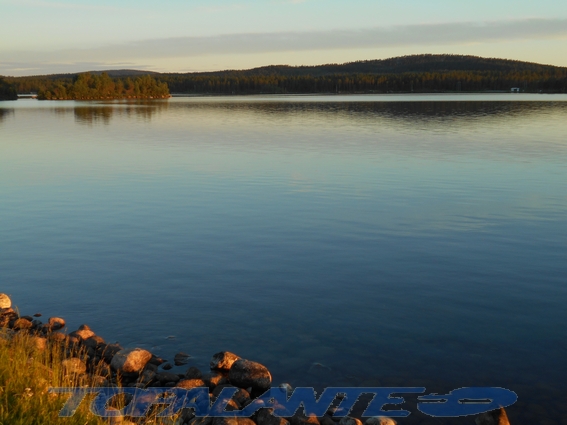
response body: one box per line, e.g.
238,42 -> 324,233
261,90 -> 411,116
183,101 -> 567,124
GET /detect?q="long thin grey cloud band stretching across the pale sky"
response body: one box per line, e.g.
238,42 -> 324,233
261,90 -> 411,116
4,19 -> 567,75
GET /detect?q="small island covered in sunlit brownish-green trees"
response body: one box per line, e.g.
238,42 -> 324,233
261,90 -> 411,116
37,72 -> 170,100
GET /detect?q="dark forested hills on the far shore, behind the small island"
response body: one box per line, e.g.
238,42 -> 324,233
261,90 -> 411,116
7,55 -> 567,94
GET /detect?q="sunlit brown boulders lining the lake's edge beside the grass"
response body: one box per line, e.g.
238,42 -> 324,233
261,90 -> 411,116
0,294 -> 509,425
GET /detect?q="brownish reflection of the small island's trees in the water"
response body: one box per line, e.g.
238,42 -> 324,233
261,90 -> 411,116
74,102 -> 168,125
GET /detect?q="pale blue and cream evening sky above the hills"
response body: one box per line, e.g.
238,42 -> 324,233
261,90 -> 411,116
0,0 -> 567,76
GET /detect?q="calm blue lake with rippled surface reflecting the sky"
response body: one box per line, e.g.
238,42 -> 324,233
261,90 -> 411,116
0,94 -> 567,425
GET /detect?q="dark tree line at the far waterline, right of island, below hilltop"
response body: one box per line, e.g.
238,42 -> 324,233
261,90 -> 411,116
160,70 -> 567,94
